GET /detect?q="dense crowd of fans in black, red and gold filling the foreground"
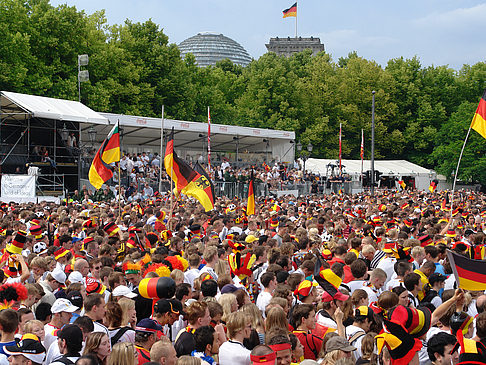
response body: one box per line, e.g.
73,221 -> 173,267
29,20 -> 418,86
0,191 -> 486,365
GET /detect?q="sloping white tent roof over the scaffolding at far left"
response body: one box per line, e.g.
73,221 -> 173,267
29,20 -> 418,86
0,91 -> 108,124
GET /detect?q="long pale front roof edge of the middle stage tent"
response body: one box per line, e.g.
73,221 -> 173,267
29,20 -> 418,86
100,113 -> 295,140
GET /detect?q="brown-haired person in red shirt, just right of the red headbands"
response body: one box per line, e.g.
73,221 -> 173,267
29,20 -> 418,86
292,304 -> 322,360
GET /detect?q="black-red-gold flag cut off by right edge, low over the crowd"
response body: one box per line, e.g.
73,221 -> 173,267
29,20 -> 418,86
447,250 -> 486,291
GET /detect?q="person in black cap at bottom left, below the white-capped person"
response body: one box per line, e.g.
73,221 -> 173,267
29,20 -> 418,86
50,324 -> 83,365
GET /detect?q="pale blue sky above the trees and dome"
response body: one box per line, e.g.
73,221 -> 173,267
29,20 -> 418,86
51,0 -> 486,69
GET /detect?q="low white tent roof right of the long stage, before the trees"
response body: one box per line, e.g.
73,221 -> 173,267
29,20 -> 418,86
305,158 -> 435,176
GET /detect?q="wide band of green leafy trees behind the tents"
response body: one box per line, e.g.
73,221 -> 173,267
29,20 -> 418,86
0,0 -> 486,183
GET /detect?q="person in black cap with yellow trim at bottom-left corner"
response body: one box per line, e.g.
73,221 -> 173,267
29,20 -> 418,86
3,333 -> 46,365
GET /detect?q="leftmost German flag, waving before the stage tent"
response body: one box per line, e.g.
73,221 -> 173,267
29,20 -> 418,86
89,123 -> 120,189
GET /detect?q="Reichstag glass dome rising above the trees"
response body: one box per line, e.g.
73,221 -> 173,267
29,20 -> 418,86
179,32 -> 251,67
